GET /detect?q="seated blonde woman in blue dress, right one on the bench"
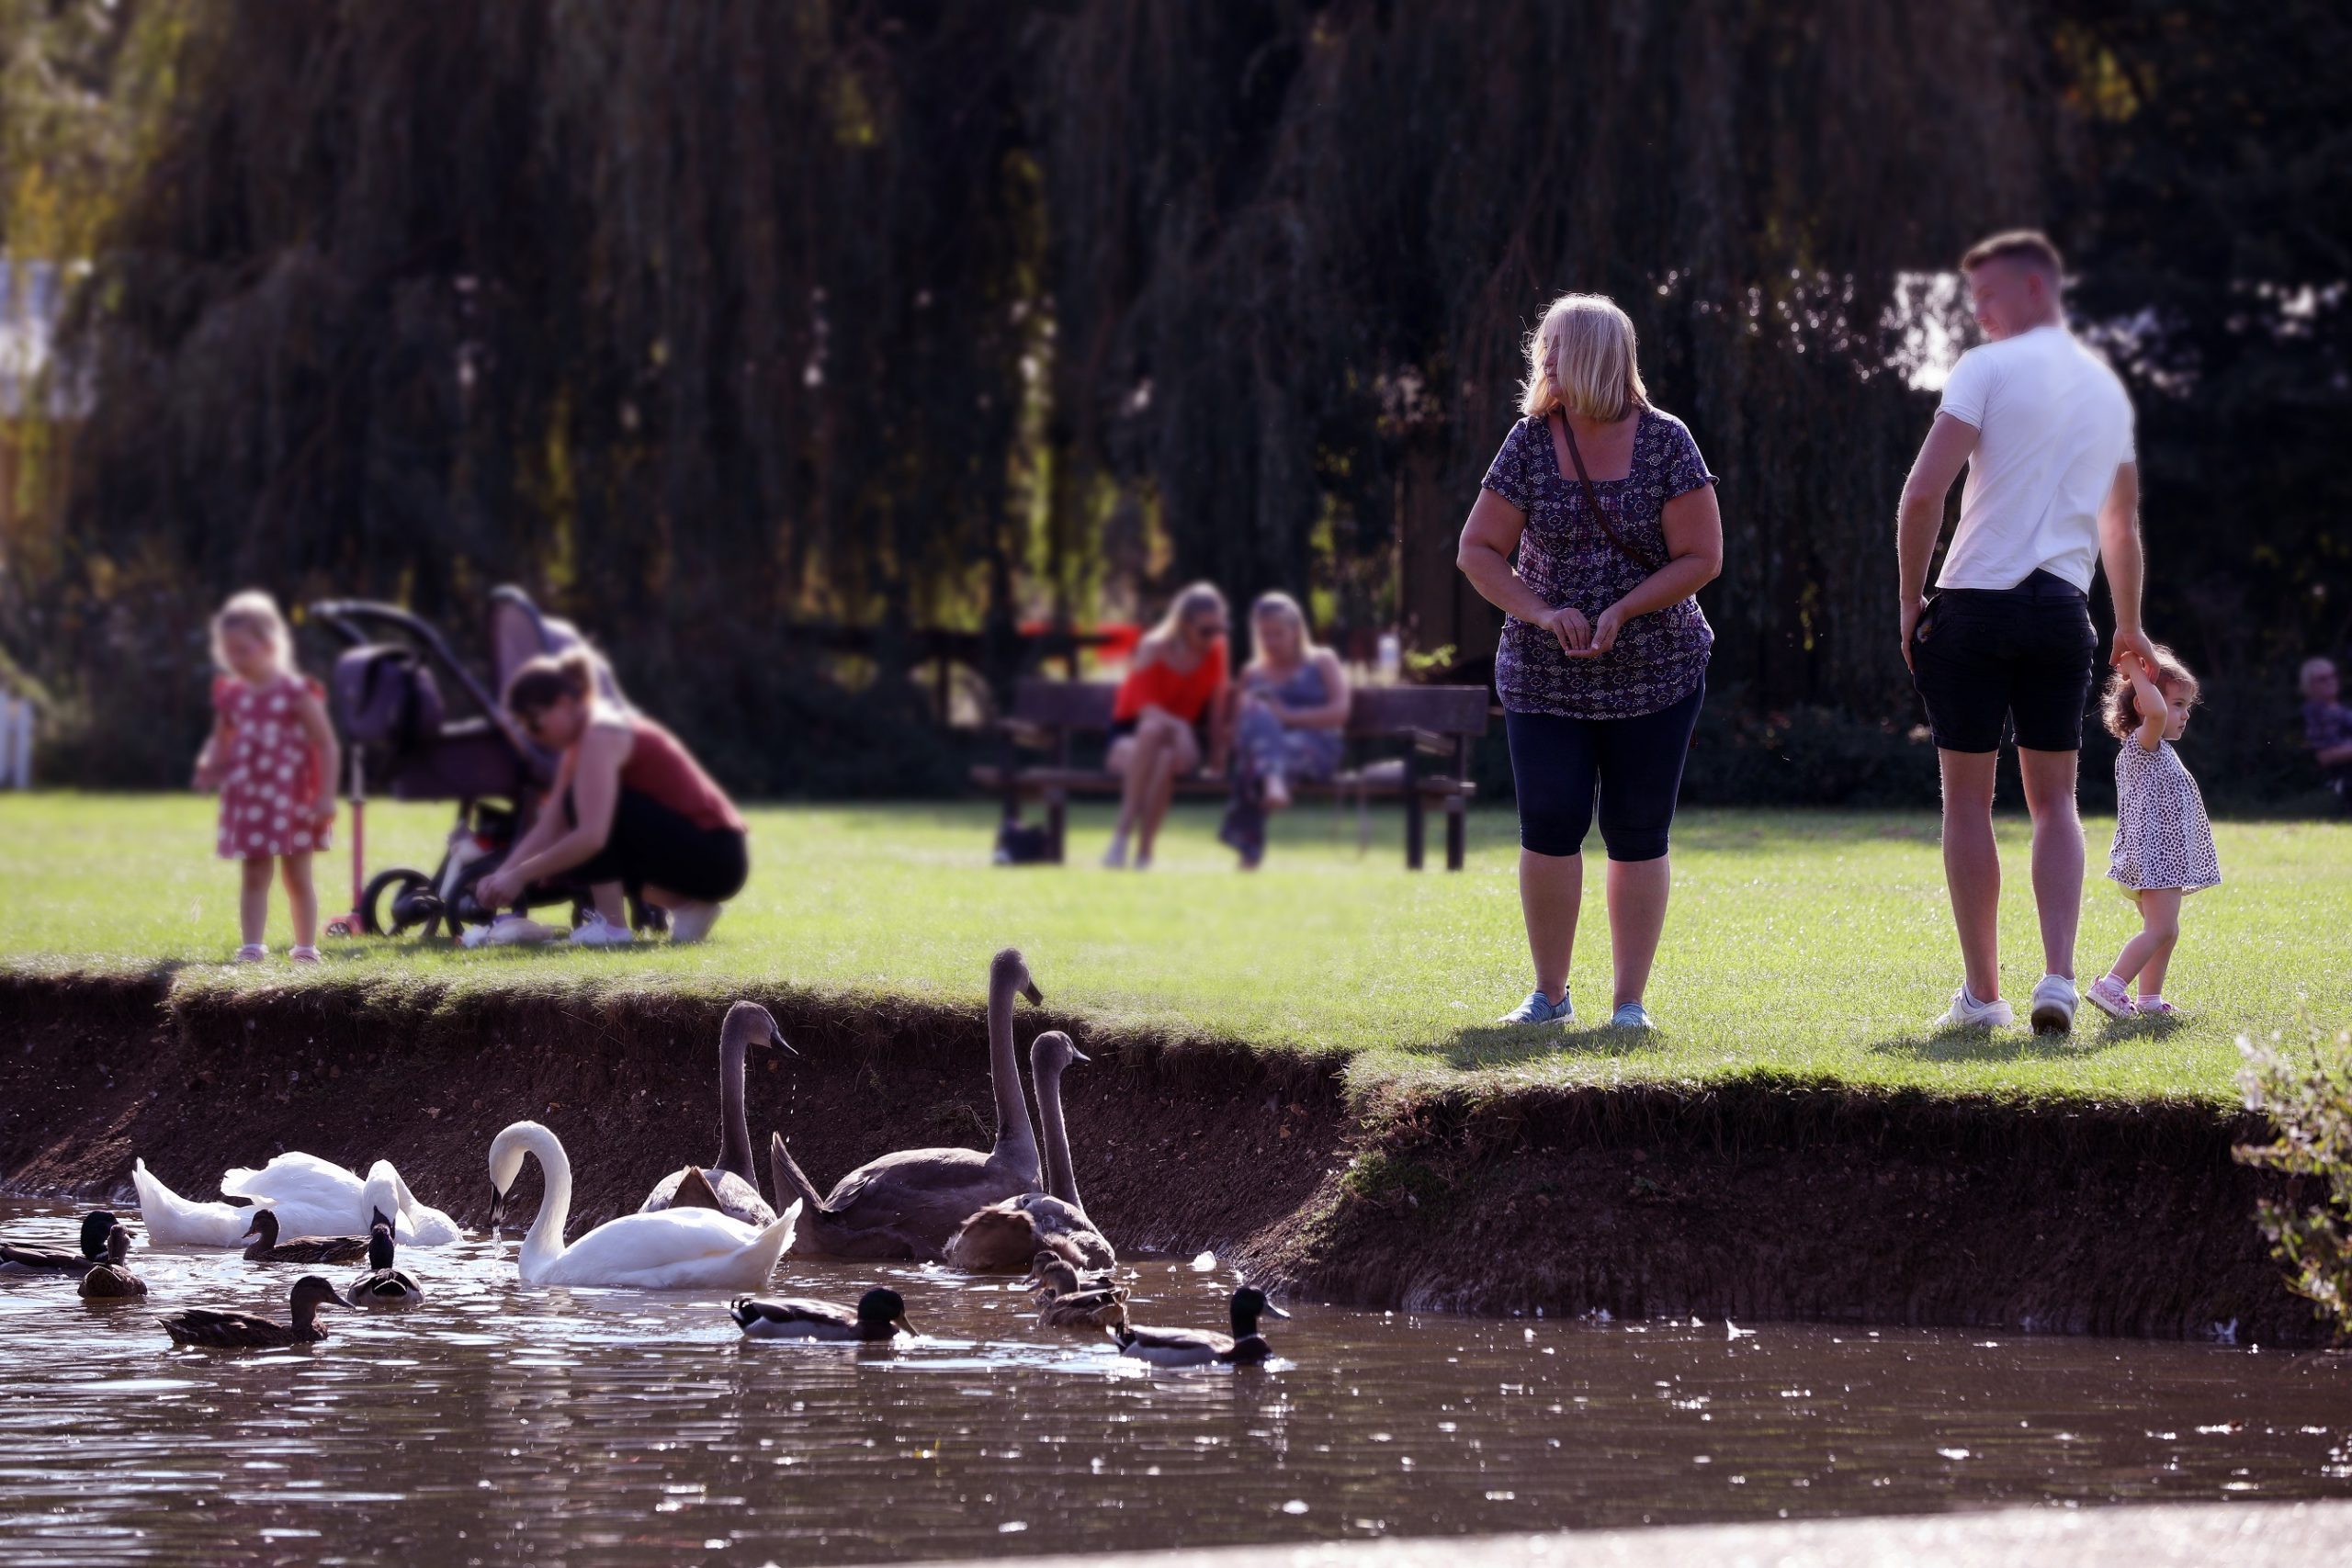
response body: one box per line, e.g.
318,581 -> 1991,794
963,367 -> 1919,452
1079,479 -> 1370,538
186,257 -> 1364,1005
1218,592 -> 1348,870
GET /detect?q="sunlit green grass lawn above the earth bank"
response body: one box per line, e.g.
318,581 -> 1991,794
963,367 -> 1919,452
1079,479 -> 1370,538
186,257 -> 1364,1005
0,795 -> 2352,1100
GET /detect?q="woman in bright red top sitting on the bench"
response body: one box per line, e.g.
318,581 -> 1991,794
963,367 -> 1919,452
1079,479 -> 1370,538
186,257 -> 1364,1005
1103,583 -> 1227,870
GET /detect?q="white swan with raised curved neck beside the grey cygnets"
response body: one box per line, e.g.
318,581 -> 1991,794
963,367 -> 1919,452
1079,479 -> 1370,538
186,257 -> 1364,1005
489,1122 -> 799,1291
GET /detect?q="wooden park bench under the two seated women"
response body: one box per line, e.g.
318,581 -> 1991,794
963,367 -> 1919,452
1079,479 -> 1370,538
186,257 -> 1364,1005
971,677 -> 1488,872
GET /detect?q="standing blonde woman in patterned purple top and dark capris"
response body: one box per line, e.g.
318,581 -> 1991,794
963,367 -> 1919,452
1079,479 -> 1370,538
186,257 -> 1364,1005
1458,294 -> 1724,1030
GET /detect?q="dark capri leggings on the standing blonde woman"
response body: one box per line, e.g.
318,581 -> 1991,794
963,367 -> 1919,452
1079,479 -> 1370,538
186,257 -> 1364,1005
1503,680 -> 1708,861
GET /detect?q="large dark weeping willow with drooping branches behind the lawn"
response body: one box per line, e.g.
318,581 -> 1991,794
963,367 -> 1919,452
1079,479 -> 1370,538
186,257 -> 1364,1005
0,0 -> 2343,790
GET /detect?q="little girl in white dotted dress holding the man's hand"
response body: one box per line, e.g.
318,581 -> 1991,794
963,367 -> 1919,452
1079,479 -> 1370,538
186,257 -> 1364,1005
2086,647 -> 2221,1018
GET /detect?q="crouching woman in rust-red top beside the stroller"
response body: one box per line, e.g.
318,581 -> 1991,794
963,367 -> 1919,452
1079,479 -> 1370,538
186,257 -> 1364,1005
475,649 -> 751,947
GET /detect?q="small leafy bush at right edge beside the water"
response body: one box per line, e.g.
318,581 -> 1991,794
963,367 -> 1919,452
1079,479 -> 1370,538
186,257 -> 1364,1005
2237,1027 -> 2352,1336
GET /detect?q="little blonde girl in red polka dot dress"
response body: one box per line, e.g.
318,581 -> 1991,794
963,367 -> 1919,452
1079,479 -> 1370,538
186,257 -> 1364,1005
195,592 -> 341,964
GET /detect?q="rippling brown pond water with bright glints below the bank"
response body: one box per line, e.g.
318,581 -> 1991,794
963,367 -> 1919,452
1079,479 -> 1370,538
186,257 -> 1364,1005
0,1203 -> 2352,1565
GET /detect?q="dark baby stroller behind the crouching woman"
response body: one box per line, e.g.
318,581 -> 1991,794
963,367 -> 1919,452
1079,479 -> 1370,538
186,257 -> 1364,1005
308,588 -> 650,938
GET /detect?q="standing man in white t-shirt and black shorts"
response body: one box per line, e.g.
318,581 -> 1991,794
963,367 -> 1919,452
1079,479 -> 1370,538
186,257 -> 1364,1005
1895,232 -> 2152,1032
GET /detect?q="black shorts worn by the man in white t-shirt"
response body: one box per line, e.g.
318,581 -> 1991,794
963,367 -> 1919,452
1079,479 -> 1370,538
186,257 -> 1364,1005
1912,571 -> 2098,752
